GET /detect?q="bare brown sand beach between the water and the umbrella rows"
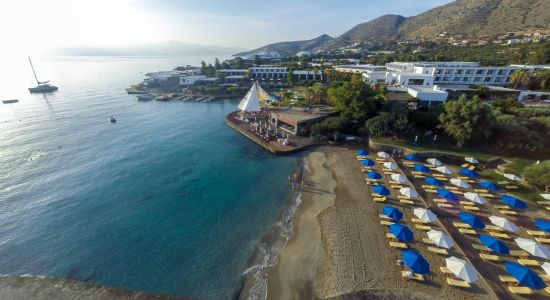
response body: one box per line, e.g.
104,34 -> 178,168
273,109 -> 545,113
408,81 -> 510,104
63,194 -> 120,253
267,147 -> 496,299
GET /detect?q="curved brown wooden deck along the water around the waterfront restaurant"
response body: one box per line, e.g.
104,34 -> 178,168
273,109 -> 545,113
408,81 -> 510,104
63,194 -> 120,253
225,111 -> 320,155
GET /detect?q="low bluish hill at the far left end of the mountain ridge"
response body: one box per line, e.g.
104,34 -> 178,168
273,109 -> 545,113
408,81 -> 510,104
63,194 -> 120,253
235,34 -> 333,56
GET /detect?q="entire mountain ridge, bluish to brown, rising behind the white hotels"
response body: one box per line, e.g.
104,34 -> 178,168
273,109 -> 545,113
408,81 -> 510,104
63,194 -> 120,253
236,0 -> 550,56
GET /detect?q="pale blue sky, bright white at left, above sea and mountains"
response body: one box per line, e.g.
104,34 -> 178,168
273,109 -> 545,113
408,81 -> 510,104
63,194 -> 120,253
0,0 -> 451,53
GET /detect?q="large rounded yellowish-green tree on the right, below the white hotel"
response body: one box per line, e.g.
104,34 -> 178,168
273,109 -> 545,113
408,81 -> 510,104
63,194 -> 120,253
438,95 -> 494,147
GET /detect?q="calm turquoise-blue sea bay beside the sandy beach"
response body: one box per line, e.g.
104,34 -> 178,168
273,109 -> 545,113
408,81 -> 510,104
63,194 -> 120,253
0,58 -> 298,299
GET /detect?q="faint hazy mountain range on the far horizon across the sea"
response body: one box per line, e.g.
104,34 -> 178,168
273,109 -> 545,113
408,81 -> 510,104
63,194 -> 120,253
48,41 -> 247,56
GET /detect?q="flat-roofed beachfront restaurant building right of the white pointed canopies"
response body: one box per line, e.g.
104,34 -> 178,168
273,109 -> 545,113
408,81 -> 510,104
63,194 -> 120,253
269,105 -> 336,136
